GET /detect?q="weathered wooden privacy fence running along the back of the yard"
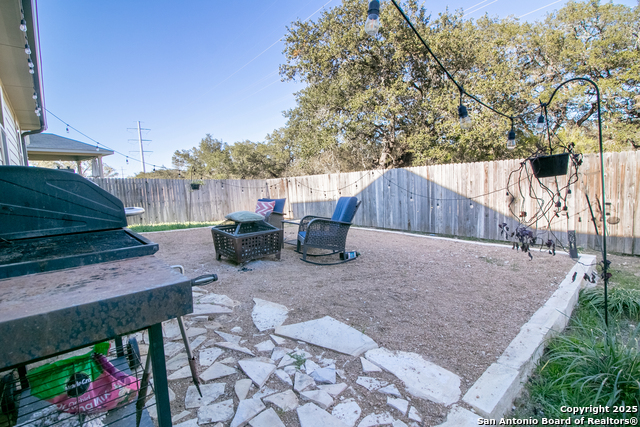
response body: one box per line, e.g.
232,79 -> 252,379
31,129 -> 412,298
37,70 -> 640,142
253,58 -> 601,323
95,151 -> 640,255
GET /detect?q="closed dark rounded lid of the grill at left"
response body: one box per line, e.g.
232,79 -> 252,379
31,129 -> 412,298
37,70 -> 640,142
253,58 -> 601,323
0,166 -> 127,240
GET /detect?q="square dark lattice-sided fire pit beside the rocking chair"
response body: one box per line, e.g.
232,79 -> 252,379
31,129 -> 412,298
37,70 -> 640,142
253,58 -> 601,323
211,221 -> 283,263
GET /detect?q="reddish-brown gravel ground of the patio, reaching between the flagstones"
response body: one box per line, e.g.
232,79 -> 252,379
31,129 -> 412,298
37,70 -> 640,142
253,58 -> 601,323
145,227 -> 574,426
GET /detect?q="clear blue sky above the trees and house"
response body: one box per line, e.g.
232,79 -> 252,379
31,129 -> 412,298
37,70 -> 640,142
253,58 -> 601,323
38,0 -> 637,177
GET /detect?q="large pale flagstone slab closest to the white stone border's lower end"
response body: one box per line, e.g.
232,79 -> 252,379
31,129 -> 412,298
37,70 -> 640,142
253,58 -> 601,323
365,348 -> 460,406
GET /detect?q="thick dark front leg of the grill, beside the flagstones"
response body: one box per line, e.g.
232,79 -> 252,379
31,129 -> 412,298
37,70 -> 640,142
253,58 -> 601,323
147,323 -> 172,427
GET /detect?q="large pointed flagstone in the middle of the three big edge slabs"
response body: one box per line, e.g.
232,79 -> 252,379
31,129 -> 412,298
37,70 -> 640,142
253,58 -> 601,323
275,316 -> 378,356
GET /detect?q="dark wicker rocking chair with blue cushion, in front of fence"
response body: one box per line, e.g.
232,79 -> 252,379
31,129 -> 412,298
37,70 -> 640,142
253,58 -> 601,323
297,197 -> 361,265
